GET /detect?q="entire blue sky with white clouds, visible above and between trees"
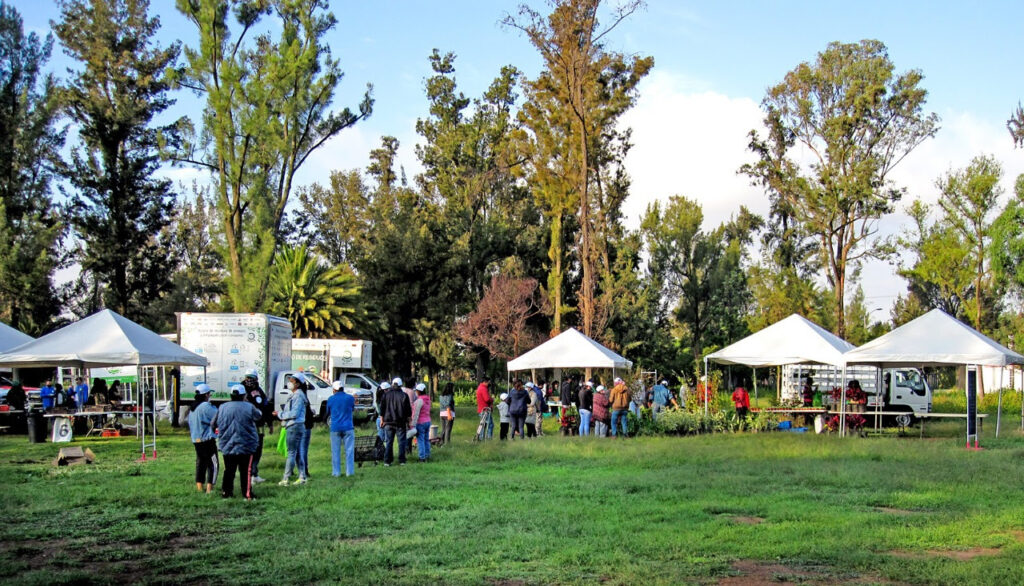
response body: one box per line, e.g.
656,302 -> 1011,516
12,0 -> 1024,317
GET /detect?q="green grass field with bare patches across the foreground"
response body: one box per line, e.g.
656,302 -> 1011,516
0,410 -> 1024,585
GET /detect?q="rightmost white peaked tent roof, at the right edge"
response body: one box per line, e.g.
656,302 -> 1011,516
846,309 -> 1024,367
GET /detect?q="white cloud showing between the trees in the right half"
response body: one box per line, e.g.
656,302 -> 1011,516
623,71 -> 1024,308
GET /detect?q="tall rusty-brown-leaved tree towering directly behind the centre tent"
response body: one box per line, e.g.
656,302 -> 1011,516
503,0 -> 654,336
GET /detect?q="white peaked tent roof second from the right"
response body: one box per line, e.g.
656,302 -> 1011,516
708,313 -> 854,367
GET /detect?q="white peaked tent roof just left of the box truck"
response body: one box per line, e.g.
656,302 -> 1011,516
0,309 -> 207,368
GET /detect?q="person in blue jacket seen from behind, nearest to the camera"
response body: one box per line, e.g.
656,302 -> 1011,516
210,384 -> 263,501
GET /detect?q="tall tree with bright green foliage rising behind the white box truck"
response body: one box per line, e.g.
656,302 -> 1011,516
176,0 -> 373,310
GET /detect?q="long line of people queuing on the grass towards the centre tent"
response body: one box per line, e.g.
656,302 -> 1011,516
182,371 -> 750,499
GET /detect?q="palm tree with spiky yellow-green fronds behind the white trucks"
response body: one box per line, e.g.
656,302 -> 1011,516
267,245 -> 367,338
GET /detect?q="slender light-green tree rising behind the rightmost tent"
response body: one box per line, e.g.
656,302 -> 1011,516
935,157 -> 1002,331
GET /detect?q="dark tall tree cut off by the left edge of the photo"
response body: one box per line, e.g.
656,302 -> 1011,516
0,2 -> 65,335
